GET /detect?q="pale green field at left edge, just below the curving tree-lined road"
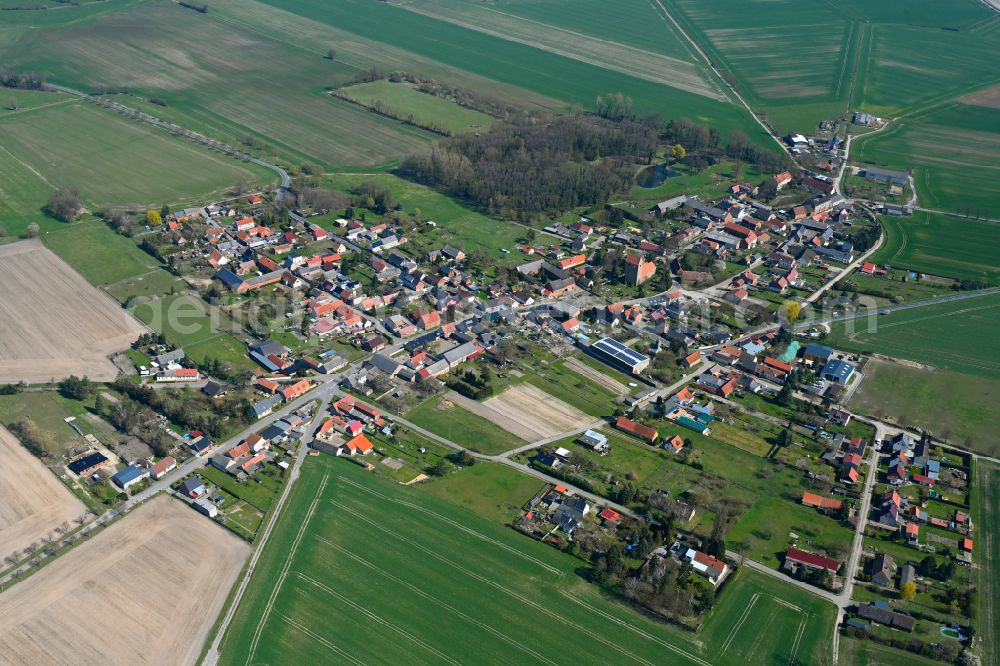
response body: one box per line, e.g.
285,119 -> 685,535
0,102 -> 275,222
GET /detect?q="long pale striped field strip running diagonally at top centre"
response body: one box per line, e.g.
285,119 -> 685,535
398,2 -> 729,101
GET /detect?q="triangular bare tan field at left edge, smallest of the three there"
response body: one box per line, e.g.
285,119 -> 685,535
0,426 -> 87,557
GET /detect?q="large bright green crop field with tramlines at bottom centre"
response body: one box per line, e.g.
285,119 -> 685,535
220,457 -> 834,666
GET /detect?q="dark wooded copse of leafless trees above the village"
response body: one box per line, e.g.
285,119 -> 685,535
400,115 -> 658,216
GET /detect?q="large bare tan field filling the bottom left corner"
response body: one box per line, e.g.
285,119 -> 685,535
0,497 -> 250,665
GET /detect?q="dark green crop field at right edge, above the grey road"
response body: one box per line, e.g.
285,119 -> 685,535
872,211 -> 1000,283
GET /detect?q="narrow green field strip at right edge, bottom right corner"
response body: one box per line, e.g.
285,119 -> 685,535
972,460 -> 1000,666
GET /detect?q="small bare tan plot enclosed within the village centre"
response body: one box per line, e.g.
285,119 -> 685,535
458,384 -> 594,442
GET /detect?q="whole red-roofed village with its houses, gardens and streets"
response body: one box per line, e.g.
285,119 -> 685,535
54,160 -> 973,649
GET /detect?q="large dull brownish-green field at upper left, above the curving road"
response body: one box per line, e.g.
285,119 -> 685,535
5,0 -> 440,166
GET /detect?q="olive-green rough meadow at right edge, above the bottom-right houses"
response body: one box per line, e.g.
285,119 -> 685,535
850,361 -> 1000,456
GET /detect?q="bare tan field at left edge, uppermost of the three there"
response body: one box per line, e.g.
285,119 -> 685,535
0,241 -> 144,383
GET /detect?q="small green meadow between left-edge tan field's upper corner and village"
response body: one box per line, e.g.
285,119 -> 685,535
42,219 -> 160,286
